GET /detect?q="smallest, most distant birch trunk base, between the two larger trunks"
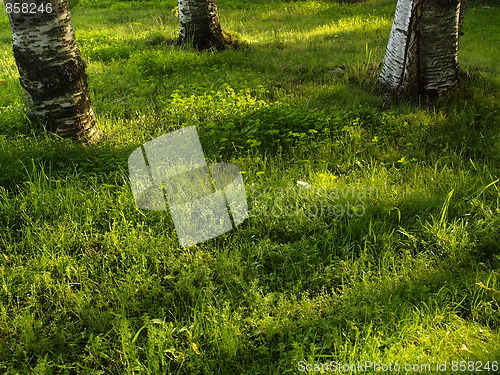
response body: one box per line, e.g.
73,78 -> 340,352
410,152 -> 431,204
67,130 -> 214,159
178,0 -> 227,51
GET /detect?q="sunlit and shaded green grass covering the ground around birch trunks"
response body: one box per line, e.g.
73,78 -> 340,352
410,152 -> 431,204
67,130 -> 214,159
0,0 -> 500,374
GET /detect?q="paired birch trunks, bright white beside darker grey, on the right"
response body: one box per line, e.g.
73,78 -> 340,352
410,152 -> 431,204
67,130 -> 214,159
379,0 -> 463,100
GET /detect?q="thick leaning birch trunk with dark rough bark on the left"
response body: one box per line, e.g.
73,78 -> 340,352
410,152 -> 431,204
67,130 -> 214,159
5,0 -> 99,141
